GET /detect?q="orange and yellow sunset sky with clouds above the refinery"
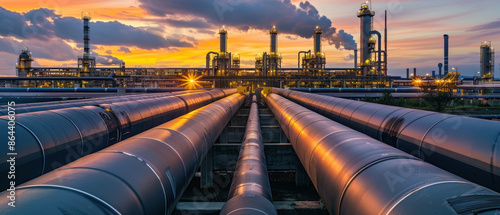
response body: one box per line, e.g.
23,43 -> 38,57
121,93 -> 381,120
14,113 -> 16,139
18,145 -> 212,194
0,0 -> 500,77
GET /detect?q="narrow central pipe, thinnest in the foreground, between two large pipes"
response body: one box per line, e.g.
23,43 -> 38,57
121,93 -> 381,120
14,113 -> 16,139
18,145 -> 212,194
220,96 -> 278,215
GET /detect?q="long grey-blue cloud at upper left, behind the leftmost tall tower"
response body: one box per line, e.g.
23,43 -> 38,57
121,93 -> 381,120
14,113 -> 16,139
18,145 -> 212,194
0,7 -> 195,50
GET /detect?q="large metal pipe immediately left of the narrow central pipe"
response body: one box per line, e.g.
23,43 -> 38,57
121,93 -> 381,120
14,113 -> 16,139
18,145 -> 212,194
0,94 -> 245,215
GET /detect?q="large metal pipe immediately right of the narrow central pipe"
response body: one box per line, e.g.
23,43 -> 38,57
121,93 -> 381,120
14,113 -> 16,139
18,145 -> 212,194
265,93 -> 500,215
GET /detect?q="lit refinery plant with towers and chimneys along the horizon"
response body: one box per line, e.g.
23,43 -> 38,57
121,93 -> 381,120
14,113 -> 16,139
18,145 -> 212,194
8,2 -> 398,89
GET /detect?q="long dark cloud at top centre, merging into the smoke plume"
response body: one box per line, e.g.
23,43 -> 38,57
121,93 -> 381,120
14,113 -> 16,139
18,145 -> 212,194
139,0 -> 356,49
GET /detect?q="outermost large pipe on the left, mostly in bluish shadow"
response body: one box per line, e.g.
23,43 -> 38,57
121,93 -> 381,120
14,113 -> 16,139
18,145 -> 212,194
0,89 -> 236,191
